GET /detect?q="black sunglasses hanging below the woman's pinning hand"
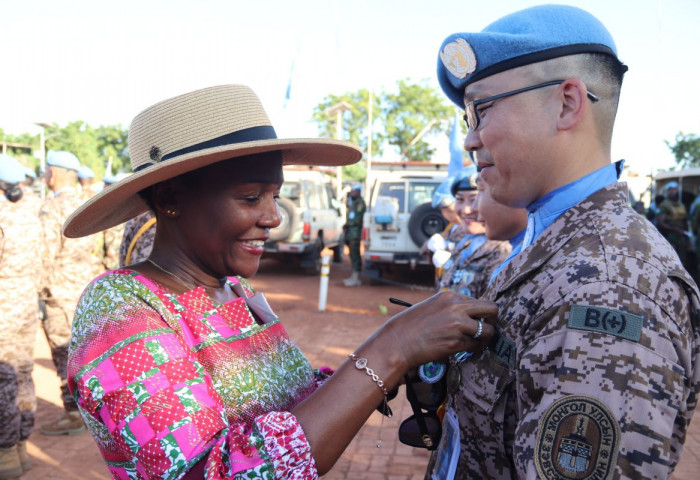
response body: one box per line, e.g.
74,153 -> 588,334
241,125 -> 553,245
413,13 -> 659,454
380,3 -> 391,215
399,375 -> 447,450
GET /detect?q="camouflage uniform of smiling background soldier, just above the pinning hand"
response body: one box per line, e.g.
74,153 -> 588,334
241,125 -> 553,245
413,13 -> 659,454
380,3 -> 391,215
438,234 -> 511,298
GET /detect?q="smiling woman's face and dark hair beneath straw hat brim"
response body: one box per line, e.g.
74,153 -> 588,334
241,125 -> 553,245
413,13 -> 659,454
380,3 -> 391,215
172,154 -> 283,278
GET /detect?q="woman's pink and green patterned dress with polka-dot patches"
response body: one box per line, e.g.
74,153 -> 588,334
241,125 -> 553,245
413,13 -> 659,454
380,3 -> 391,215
68,270 -> 330,479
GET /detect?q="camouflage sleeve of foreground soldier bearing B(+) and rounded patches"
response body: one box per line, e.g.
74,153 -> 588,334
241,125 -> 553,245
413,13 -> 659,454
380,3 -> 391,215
514,282 -> 697,478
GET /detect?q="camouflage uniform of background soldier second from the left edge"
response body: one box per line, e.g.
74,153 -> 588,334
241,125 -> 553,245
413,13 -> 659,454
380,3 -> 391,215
39,190 -> 104,411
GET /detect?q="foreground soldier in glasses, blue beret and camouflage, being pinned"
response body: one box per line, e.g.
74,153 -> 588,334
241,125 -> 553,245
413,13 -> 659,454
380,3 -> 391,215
426,5 -> 700,479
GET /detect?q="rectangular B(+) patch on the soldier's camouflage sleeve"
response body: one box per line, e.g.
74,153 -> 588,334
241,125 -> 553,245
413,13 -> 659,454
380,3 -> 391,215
568,305 -> 644,342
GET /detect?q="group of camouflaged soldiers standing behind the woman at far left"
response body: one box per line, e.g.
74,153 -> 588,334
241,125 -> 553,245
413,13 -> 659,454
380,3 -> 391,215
0,151 -> 155,479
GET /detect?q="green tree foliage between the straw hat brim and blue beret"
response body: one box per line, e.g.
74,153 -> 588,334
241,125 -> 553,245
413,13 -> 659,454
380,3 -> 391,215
313,80 -> 453,169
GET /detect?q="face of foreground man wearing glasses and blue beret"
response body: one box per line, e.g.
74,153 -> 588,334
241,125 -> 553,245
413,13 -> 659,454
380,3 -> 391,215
464,69 -> 557,207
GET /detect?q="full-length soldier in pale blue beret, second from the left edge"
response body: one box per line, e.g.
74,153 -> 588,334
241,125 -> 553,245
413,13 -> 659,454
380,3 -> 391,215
39,151 -> 104,435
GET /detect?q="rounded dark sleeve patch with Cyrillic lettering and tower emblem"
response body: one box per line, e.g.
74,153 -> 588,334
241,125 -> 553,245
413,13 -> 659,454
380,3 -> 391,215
535,395 -> 620,480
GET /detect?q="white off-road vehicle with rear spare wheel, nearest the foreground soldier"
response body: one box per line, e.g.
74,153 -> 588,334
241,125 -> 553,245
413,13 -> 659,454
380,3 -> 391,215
362,162 -> 447,279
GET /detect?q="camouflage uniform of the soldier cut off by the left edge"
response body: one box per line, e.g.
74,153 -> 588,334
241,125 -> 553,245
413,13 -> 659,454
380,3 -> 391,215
0,196 -> 44,448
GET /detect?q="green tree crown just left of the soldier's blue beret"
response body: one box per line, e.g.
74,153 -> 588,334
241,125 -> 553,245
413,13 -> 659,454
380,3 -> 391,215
382,80 -> 454,162
